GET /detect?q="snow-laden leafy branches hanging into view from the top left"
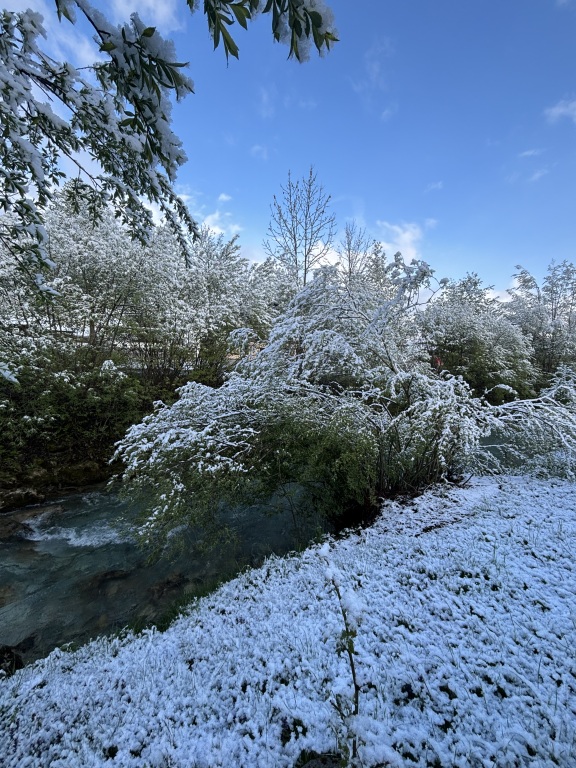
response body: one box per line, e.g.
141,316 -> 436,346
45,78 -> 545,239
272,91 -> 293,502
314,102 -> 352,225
0,0 -> 336,284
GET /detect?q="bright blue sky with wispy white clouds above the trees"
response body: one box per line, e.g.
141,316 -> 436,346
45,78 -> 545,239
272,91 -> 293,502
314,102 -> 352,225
12,0 -> 576,290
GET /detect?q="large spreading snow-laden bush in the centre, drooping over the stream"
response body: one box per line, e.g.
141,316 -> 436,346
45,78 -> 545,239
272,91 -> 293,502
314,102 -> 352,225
117,258 -> 576,550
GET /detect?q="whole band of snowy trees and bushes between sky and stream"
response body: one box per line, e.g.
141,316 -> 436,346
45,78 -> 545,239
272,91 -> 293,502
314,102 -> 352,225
0,169 -> 576,543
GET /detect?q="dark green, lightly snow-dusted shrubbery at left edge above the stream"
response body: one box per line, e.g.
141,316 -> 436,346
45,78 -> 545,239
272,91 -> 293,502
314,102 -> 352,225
0,339 -> 146,487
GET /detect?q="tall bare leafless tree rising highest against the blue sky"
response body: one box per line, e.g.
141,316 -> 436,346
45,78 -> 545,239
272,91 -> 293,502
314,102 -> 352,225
263,166 -> 336,288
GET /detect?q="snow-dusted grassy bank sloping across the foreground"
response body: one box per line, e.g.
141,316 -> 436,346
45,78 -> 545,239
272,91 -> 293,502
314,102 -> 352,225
0,477 -> 576,768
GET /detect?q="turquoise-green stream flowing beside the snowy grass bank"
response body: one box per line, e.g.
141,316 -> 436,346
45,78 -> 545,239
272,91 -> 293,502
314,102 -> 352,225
0,490 -> 320,662
